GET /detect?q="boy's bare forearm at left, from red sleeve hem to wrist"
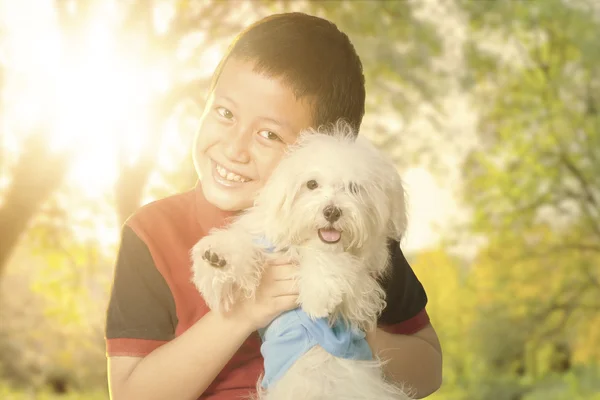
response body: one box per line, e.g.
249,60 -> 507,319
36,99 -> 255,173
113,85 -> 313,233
108,312 -> 253,400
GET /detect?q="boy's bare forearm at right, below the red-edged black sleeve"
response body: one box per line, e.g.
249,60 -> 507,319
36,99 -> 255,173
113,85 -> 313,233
367,324 -> 442,399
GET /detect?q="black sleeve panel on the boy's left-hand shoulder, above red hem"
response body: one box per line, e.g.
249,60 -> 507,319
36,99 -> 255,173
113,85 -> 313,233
106,225 -> 177,341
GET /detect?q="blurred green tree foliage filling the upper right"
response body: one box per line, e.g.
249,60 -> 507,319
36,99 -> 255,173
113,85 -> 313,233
465,0 -> 600,238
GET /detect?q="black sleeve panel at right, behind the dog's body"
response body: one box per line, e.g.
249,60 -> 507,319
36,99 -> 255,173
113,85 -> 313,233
379,240 -> 427,325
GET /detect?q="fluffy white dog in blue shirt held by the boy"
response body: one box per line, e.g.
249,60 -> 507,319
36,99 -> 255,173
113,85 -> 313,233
192,123 -> 409,400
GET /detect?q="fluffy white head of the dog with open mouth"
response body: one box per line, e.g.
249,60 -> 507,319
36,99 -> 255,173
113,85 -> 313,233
255,124 -> 407,251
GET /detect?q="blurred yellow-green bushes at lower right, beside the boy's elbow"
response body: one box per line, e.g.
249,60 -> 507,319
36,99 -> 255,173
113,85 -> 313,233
411,240 -> 600,400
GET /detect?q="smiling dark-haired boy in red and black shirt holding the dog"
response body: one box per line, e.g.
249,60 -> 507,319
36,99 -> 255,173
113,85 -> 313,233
106,13 -> 441,400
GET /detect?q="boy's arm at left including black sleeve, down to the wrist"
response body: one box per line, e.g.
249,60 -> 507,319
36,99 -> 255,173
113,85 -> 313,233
106,225 -> 252,400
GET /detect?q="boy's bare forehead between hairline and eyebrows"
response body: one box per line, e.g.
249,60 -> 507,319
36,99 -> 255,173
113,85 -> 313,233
214,58 -> 312,132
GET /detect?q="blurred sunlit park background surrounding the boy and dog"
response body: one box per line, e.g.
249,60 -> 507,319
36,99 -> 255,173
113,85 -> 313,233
0,0 -> 600,400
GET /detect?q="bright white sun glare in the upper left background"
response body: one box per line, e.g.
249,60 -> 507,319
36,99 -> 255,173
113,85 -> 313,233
0,0 -> 170,197
